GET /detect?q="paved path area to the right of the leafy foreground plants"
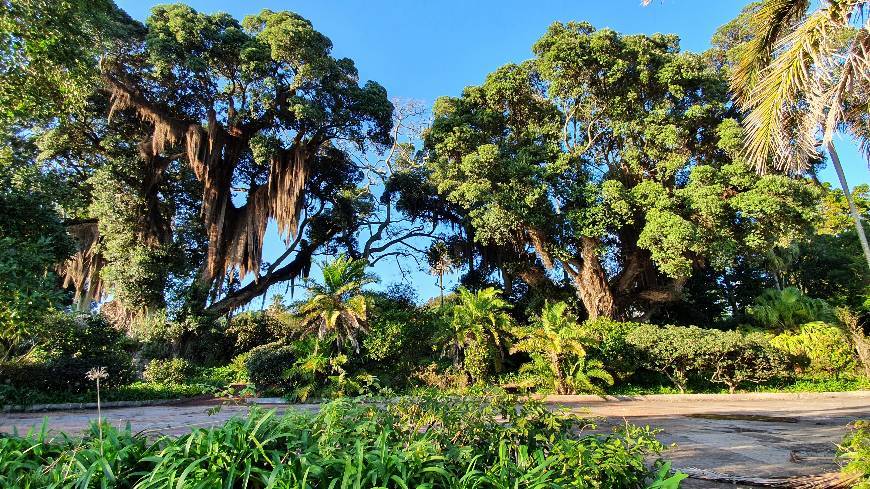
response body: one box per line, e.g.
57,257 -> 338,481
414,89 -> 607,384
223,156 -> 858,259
559,393 -> 870,488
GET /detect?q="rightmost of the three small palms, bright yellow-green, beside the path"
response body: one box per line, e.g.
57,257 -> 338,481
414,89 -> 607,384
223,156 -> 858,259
511,302 -> 613,394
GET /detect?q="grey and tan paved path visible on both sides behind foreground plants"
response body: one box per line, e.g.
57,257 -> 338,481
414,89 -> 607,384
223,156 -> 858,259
0,392 -> 870,488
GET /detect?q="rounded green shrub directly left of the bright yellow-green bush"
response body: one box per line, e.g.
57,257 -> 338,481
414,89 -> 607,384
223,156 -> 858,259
700,330 -> 789,394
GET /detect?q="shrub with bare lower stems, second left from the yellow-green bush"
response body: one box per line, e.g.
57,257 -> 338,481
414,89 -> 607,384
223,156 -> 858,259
626,324 -> 707,392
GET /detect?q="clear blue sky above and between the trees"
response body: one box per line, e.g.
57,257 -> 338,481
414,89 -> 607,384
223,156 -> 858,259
116,0 -> 870,299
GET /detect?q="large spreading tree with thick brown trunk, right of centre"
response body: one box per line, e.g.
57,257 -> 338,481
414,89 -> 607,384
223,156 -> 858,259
425,23 -> 814,317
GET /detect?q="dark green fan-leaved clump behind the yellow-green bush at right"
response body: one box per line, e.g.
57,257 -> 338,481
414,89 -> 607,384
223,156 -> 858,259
749,287 -> 836,331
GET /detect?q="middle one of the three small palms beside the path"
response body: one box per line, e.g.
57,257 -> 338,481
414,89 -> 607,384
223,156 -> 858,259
445,287 -> 513,380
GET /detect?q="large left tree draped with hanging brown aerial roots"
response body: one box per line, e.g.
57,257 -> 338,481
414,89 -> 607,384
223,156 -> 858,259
27,4 -> 393,314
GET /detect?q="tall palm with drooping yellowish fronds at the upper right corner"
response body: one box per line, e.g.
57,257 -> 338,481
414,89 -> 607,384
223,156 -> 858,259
731,0 -> 870,267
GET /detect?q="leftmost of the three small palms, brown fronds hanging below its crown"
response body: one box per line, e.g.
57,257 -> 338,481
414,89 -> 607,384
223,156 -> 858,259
298,255 -> 375,351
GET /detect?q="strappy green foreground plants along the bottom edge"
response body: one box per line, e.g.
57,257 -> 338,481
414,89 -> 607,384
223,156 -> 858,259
0,396 -> 682,489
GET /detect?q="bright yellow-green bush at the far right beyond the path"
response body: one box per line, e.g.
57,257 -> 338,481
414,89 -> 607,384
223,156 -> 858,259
770,321 -> 857,377
